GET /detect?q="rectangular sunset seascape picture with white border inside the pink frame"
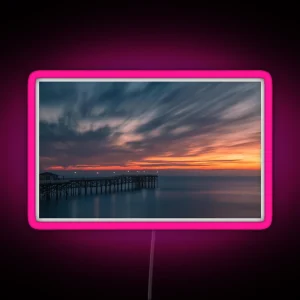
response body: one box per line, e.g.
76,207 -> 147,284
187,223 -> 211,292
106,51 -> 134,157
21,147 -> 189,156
36,79 -> 264,222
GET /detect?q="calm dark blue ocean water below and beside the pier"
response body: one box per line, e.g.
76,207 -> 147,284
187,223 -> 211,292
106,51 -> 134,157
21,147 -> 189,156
39,176 -> 261,218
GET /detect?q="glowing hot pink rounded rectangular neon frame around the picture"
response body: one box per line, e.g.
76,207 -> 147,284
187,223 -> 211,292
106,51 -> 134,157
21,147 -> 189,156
28,70 -> 272,230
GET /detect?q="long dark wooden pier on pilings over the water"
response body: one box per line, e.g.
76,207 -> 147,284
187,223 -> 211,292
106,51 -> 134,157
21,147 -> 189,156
39,175 -> 158,199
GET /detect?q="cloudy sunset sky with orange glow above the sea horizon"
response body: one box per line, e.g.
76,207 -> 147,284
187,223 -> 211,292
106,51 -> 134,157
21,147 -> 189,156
39,82 -> 261,174
